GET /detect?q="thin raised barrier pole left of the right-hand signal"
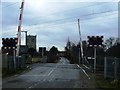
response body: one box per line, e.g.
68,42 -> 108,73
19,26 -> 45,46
78,19 -> 83,65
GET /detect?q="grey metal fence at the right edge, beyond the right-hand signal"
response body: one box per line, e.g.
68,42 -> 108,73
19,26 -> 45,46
104,57 -> 120,79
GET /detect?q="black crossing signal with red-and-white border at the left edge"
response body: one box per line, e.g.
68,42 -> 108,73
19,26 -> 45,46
2,38 -> 17,49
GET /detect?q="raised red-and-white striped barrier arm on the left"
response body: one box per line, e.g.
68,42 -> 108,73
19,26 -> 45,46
16,0 -> 24,57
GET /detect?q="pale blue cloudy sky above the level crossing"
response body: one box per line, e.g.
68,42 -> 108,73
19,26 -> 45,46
0,0 -> 118,50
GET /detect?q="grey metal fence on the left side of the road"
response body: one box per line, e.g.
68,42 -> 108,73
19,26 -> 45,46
2,54 -> 26,73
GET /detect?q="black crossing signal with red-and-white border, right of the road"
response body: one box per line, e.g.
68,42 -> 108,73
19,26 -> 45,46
88,36 -> 103,47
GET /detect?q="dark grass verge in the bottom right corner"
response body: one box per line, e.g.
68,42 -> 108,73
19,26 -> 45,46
95,74 -> 120,90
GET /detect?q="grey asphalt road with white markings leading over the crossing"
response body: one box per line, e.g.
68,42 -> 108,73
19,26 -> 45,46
3,58 -> 94,90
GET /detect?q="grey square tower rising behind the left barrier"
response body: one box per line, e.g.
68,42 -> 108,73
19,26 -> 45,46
27,35 -> 36,49
